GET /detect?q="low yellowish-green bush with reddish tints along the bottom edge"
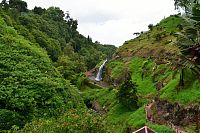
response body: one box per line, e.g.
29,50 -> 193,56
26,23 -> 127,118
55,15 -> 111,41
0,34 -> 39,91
19,109 -> 109,133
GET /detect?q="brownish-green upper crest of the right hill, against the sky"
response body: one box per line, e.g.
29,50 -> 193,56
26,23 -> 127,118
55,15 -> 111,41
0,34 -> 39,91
117,16 -> 181,58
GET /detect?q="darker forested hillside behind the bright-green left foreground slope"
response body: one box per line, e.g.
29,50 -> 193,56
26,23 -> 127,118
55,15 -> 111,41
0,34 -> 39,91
0,3 -> 116,78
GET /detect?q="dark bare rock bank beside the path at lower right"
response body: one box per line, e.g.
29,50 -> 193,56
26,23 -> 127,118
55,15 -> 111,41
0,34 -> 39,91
156,100 -> 200,126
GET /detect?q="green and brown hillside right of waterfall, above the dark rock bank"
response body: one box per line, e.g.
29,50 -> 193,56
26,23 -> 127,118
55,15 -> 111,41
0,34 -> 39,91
108,15 -> 200,105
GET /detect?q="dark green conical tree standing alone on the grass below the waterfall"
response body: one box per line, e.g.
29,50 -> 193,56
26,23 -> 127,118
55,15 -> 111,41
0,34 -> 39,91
117,75 -> 138,110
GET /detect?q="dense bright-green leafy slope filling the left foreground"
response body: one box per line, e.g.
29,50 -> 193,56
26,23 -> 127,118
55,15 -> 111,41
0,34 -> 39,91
0,12 -> 81,129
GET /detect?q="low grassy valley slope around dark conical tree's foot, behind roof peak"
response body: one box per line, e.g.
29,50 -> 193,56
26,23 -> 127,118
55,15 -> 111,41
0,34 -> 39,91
82,88 -> 172,133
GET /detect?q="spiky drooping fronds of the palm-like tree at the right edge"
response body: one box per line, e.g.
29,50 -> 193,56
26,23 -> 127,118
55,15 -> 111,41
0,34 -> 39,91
176,4 -> 200,72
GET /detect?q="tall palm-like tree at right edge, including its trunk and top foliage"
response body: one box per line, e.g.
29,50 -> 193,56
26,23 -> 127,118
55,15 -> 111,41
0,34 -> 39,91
171,0 -> 200,92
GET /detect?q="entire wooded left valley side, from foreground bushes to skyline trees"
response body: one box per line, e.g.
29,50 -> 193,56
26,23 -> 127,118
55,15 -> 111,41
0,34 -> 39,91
0,0 -> 116,132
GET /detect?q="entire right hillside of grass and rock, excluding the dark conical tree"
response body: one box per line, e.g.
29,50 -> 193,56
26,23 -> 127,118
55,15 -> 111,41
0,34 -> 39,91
83,15 -> 200,133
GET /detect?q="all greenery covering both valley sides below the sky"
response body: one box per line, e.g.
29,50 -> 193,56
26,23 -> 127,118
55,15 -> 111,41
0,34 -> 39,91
0,0 -> 200,133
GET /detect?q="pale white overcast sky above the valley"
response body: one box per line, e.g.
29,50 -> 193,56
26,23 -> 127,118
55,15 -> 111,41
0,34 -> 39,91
25,0 -> 176,46
